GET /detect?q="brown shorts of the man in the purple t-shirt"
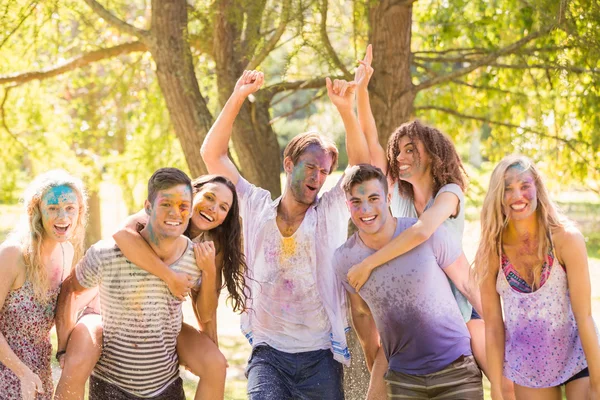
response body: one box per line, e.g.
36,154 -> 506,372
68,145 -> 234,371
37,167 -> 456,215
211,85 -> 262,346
385,356 -> 483,400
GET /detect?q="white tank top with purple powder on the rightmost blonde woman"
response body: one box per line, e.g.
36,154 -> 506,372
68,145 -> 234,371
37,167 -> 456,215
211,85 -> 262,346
496,247 -> 598,388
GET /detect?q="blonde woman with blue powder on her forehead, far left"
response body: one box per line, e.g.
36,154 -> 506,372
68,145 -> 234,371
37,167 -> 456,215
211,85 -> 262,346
0,170 -> 87,400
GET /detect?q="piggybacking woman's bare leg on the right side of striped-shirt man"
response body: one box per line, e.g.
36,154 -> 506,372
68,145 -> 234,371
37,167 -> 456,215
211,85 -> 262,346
177,324 -> 227,400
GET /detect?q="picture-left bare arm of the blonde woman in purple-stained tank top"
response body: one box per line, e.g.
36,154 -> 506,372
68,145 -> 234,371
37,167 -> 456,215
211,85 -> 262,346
480,260 -> 504,400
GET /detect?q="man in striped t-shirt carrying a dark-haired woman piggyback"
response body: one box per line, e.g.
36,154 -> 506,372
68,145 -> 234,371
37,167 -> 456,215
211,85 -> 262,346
59,168 -> 200,400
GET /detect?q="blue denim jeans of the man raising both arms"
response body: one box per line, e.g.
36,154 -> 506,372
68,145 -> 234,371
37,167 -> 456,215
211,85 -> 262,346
246,344 -> 344,400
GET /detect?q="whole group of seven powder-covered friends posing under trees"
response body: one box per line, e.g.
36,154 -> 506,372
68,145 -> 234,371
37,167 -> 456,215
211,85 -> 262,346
0,46 -> 600,400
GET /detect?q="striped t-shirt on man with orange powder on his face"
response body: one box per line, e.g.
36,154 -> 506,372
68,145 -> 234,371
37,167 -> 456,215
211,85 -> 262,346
76,240 -> 201,397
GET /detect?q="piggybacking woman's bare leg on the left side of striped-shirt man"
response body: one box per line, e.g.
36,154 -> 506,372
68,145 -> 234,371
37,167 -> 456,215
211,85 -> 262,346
54,314 -> 102,400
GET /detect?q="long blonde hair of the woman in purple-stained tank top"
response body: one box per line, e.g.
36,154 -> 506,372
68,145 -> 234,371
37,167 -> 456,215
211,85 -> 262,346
474,155 -> 571,290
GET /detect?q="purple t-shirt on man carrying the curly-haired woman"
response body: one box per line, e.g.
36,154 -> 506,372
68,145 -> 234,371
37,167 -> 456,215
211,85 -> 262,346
334,218 -> 471,375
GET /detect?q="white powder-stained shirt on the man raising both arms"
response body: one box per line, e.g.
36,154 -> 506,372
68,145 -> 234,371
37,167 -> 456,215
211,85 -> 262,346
236,177 -> 350,364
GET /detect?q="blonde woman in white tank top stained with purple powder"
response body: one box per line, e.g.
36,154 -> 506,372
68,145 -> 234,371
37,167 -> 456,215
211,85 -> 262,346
475,156 -> 600,400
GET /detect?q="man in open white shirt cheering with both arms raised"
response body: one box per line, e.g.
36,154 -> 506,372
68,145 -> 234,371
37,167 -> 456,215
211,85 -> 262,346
201,71 -> 369,400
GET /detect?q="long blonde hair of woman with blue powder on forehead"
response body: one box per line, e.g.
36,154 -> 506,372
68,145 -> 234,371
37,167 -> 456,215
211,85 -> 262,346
9,170 -> 87,301
